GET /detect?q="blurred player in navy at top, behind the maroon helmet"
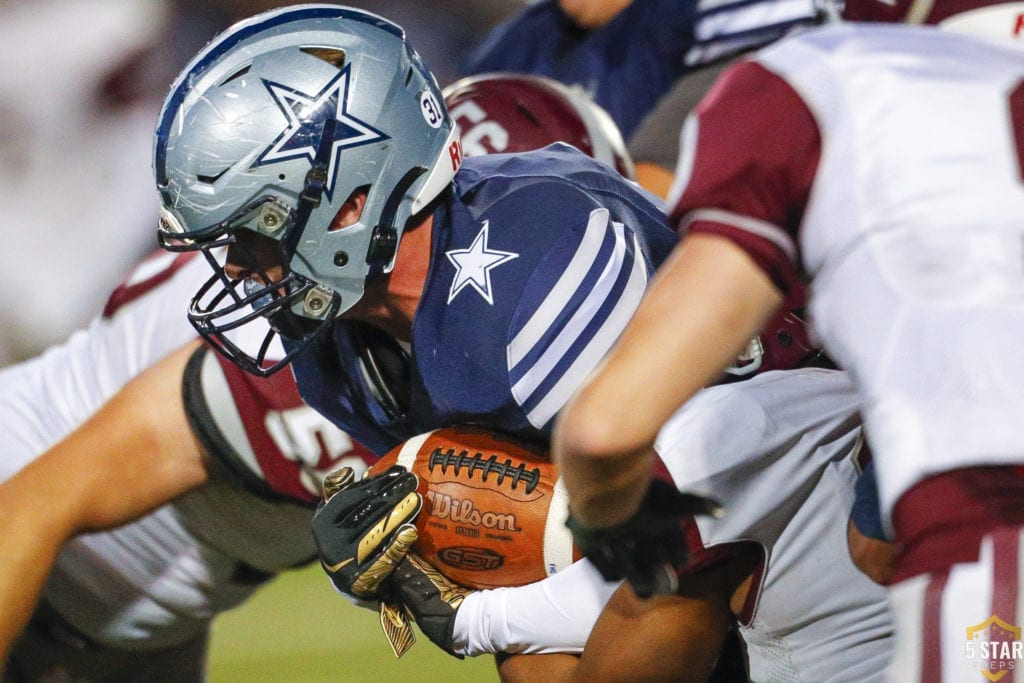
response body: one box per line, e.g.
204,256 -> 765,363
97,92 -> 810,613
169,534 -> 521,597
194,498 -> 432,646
464,0 -> 836,197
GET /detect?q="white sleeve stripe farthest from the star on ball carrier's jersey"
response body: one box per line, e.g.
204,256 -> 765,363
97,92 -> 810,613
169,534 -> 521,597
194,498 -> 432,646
513,232 -> 650,428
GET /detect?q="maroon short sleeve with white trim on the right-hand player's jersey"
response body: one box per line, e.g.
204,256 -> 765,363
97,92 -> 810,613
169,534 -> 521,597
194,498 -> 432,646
670,60 -> 821,299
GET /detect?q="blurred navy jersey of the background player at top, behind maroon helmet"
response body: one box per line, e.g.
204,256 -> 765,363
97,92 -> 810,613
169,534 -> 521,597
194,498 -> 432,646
464,0 -> 831,139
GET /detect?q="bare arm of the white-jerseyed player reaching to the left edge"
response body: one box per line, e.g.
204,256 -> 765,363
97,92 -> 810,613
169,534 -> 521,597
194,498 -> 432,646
0,341 -> 207,661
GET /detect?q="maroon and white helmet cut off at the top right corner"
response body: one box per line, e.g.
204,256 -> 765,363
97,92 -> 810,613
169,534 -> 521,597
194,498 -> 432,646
843,0 -> 1024,41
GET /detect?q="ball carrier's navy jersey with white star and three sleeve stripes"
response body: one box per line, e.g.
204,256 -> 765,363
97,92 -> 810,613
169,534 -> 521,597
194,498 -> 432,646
293,144 -> 676,453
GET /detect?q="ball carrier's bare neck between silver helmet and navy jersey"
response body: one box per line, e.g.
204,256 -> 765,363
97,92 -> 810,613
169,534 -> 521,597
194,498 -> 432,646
345,214 -> 433,342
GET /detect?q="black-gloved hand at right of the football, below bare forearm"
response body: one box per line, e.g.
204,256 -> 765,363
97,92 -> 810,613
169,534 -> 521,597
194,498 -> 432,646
565,479 -> 721,598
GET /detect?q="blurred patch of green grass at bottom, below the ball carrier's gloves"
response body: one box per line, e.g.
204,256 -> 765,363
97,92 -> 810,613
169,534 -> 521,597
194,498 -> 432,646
210,565 -> 498,683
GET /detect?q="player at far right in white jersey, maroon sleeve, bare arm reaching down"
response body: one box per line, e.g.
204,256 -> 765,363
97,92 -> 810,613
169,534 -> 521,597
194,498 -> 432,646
555,0 -> 1024,681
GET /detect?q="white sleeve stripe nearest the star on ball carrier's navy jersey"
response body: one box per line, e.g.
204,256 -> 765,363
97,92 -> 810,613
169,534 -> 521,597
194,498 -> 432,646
506,209 -> 609,368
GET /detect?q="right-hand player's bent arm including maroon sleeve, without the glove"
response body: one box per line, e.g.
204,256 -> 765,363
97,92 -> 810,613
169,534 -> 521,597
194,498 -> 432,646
553,62 -> 820,540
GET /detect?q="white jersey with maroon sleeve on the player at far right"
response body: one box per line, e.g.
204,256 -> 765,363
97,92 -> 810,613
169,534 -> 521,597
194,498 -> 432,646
673,25 -> 1024,514
